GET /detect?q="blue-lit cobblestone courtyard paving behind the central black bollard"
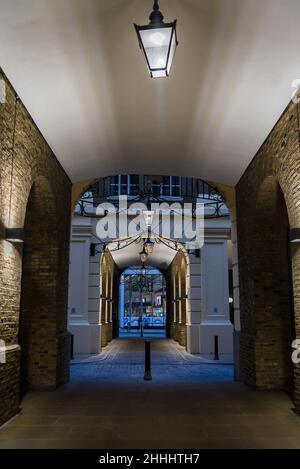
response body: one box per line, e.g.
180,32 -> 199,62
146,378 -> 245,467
71,339 -> 233,382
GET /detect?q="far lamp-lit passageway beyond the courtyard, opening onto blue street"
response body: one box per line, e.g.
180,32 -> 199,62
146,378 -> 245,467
100,240 -> 190,348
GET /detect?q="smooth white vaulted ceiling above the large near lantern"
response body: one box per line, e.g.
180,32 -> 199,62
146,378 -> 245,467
0,0 -> 300,184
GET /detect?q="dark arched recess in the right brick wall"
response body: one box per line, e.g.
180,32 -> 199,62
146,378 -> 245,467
240,176 -> 295,391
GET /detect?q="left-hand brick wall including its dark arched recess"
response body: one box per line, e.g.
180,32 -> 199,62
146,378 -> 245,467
0,70 -> 71,424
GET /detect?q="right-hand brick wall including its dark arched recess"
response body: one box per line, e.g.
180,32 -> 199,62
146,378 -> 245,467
236,103 -> 300,408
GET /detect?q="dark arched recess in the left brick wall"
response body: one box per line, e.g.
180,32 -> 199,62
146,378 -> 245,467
19,176 -> 69,394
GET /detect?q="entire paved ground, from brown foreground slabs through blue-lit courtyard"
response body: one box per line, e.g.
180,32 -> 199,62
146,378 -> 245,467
0,342 -> 300,449
